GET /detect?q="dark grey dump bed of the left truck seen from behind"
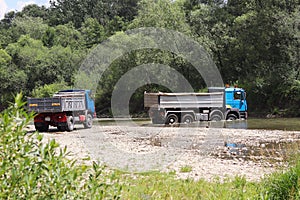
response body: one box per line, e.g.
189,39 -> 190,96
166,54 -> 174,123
27,92 -> 86,113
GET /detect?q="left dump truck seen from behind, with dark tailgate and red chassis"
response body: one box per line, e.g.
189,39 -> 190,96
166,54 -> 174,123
27,90 -> 96,132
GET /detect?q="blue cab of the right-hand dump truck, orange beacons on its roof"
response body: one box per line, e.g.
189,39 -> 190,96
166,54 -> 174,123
225,87 -> 248,119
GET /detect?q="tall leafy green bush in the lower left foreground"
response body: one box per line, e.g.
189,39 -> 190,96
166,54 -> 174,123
0,94 -> 122,199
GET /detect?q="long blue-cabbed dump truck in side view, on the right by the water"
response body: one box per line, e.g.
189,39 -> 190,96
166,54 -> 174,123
144,87 -> 248,124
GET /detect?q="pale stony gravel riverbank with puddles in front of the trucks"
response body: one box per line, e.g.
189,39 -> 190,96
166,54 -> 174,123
29,122 -> 300,181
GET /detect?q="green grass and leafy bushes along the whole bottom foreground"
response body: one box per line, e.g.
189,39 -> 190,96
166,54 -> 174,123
0,95 -> 300,199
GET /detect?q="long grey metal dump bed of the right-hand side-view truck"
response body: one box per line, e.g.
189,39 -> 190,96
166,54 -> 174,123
144,92 -> 224,108
